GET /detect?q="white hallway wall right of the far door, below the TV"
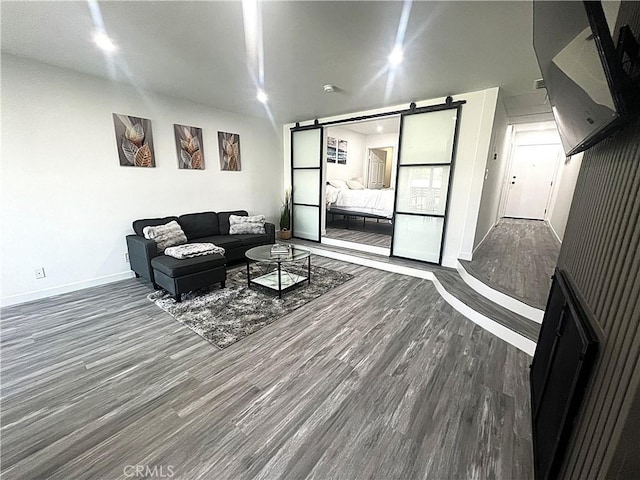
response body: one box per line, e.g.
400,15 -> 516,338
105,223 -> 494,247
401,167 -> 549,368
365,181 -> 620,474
547,153 -> 582,241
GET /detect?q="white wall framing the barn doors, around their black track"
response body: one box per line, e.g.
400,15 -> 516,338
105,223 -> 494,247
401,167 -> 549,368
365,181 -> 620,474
282,87 -> 498,268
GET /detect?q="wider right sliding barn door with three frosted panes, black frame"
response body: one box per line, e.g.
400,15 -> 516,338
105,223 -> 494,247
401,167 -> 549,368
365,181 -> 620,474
391,106 -> 461,264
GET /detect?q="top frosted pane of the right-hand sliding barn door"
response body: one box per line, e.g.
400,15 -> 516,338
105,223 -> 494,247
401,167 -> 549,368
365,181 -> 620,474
399,109 -> 458,165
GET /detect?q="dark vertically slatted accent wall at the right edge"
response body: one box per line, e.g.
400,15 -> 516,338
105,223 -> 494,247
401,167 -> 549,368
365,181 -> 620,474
558,109 -> 640,480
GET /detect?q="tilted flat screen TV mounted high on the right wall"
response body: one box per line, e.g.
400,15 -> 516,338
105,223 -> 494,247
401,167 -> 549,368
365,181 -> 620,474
533,0 -> 631,155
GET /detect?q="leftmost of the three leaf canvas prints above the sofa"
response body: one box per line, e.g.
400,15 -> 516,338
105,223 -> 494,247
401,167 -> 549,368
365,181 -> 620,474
113,113 -> 156,167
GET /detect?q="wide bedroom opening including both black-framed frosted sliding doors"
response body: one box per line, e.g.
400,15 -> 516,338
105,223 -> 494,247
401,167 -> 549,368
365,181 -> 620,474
291,97 -> 466,265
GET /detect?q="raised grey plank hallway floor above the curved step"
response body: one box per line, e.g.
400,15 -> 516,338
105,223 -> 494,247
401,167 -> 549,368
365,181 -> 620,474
460,218 -> 560,309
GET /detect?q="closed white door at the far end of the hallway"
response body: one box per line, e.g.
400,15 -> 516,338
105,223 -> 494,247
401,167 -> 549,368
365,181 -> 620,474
504,145 -> 560,220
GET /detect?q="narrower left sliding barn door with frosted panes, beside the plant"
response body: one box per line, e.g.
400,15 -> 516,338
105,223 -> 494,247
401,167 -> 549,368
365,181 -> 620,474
291,127 -> 323,242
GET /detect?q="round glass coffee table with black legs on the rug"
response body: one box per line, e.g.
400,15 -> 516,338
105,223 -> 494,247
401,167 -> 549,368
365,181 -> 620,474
245,245 -> 311,298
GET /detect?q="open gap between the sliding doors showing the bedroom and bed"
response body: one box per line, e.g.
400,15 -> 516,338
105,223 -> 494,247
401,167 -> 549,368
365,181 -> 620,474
321,115 -> 400,256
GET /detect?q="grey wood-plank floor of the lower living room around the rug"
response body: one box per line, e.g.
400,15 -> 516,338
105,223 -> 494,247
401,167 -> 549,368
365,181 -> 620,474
0,256 -> 533,480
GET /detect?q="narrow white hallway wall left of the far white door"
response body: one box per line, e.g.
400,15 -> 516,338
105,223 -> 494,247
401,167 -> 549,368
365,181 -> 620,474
473,90 -> 511,251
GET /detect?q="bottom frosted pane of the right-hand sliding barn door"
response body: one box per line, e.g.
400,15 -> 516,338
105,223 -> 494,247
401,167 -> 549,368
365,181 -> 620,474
393,214 -> 444,263
